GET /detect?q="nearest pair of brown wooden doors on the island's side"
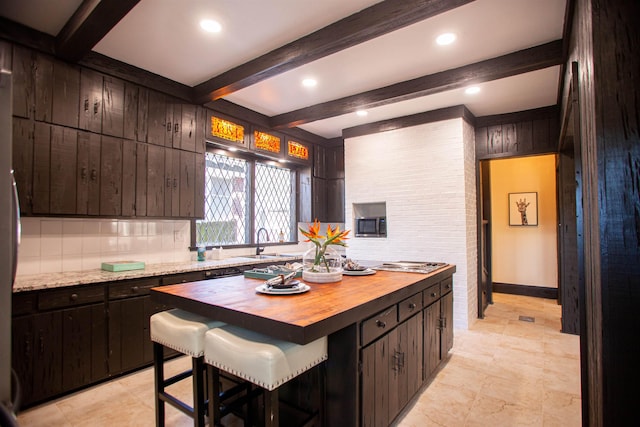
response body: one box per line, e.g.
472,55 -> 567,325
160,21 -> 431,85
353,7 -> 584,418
362,315 -> 422,426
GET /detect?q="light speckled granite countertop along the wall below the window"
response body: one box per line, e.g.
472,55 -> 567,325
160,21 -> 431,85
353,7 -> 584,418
13,256 -> 300,293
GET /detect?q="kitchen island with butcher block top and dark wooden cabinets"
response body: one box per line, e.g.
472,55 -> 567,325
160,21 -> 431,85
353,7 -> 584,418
151,265 -> 455,426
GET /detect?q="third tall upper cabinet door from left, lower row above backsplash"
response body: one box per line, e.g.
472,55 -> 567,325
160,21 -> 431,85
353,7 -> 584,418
50,126 -> 78,214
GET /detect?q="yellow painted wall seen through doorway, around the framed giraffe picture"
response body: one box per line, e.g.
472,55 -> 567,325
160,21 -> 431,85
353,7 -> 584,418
491,155 -> 558,288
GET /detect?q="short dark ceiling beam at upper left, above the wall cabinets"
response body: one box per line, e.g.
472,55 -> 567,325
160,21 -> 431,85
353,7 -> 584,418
56,0 -> 140,62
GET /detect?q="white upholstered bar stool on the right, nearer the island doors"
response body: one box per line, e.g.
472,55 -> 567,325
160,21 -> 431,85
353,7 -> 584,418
204,325 -> 328,426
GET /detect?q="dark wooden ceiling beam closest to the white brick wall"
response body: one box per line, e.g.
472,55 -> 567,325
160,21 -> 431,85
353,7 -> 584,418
269,40 -> 564,129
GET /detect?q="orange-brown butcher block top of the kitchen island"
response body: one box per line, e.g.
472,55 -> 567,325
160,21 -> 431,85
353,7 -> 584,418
151,265 -> 455,344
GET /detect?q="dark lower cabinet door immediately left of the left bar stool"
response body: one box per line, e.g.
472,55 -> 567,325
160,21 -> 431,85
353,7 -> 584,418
109,295 -> 150,375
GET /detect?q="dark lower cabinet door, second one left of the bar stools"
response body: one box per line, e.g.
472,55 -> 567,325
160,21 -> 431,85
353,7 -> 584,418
62,304 -> 108,391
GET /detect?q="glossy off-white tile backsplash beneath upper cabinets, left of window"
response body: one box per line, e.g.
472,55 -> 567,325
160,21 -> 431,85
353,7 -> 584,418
18,217 -> 193,275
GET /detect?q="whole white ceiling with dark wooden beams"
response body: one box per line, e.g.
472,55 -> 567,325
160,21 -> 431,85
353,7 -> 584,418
0,0 -> 568,139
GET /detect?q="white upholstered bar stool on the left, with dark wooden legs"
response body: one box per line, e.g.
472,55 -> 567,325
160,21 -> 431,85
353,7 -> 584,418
149,309 -> 224,427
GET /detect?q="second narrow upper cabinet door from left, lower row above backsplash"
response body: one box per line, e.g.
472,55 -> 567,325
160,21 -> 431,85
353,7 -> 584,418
33,122 -> 51,214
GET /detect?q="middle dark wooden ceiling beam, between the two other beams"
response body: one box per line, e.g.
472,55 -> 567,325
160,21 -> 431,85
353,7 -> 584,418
193,0 -> 473,104
